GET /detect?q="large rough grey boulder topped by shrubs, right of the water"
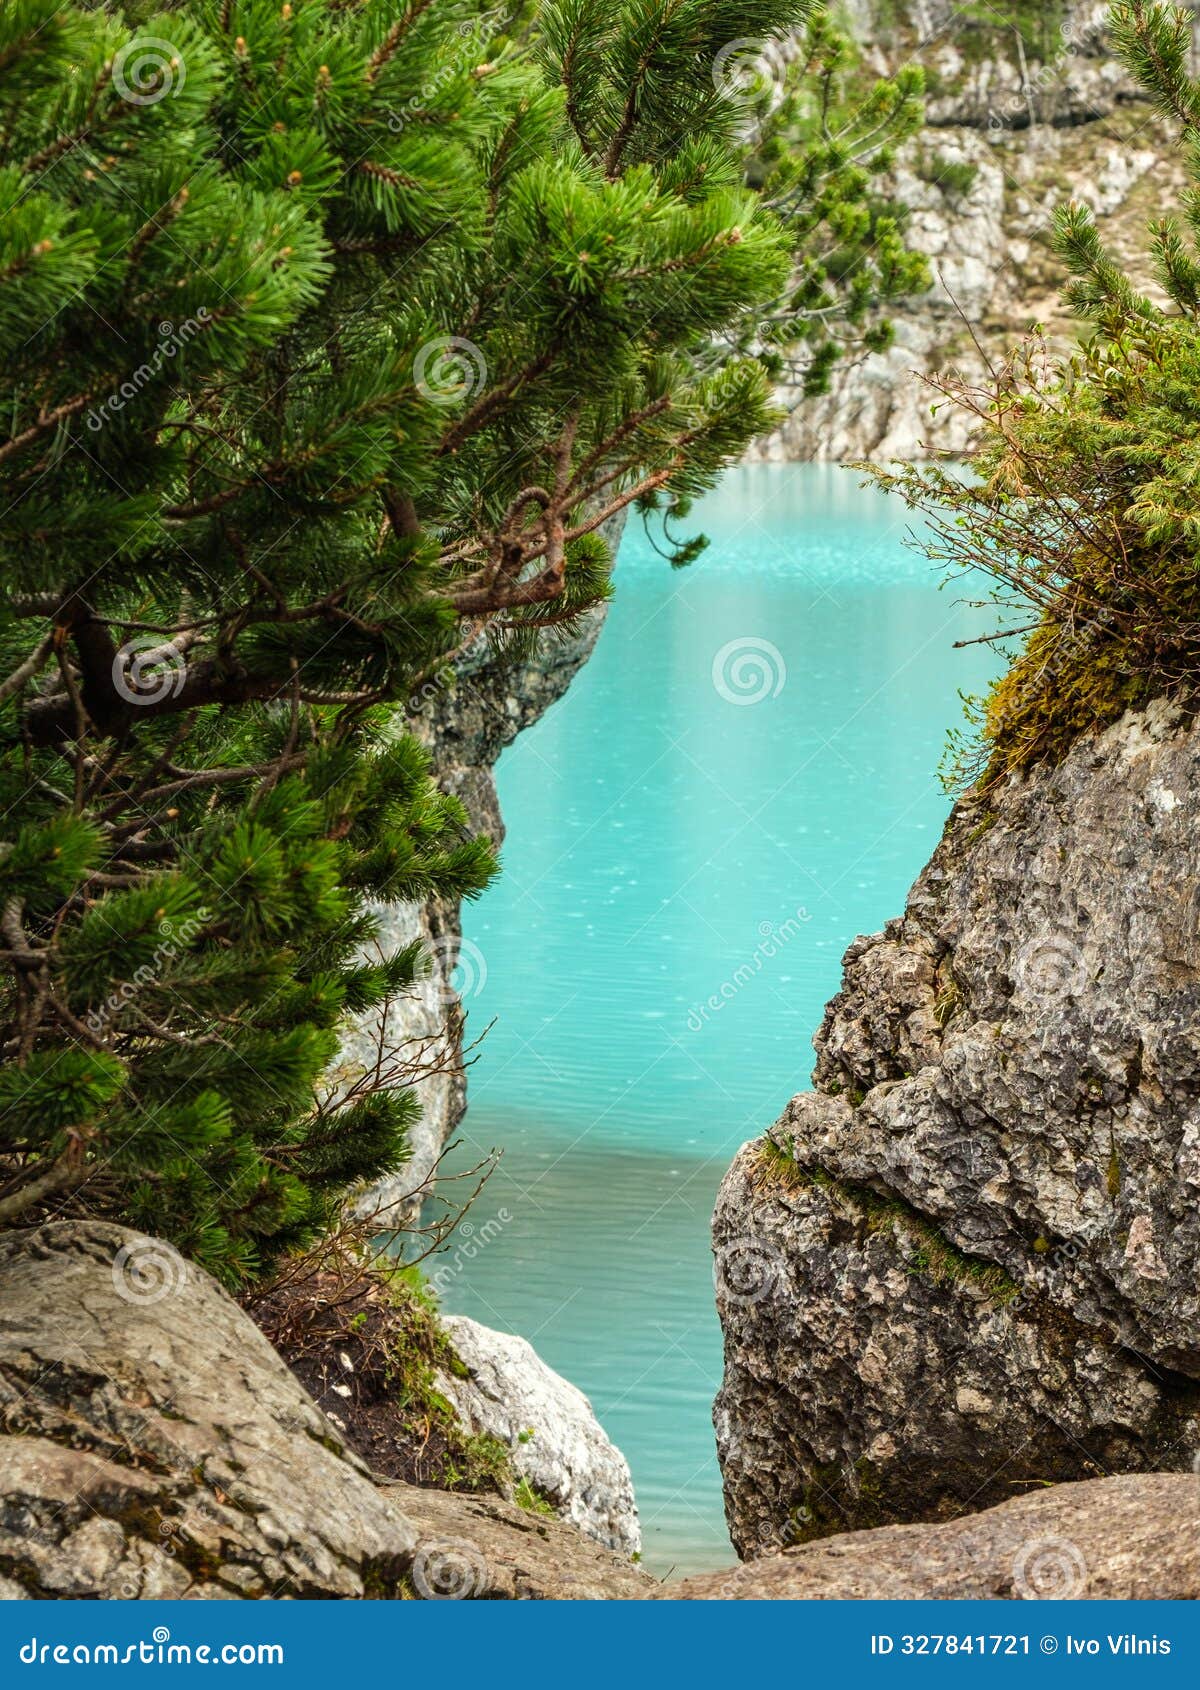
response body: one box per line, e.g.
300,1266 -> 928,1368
713,706 -> 1200,1555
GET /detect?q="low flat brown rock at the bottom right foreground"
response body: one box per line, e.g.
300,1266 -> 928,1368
661,1474 -> 1200,1602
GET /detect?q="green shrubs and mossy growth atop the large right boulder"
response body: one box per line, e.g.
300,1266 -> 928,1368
879,0 -> 1200,782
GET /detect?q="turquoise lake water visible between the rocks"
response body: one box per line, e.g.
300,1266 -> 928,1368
428,465 -> 995,1575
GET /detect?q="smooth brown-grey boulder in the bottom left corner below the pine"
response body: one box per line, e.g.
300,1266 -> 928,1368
0,1222 -> 647,1599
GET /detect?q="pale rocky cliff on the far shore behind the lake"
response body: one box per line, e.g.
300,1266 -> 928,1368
755,0 -> 1183,461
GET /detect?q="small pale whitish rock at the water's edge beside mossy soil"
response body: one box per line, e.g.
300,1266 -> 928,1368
441,1315 -> 642,1555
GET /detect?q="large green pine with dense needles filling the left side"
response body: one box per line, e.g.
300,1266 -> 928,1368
0,0 -> 912,1284
